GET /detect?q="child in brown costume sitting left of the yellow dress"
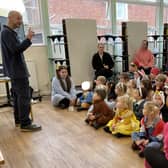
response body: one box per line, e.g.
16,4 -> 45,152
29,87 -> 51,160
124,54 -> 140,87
85,85 -> 114,129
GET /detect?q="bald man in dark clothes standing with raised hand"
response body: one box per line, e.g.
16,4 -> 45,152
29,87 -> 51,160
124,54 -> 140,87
1,11 -> 41,131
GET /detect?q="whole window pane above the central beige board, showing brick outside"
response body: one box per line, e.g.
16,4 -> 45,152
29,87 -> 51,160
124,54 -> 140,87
48,0 -> 111,35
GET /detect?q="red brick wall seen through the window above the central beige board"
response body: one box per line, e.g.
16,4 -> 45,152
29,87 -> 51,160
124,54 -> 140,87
48,0 -> 110,26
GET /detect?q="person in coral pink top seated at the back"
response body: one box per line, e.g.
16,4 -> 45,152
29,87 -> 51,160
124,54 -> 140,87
133,40 -> 154,75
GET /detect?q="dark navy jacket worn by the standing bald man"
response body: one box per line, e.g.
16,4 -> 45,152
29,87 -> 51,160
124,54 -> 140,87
1,26 -> 31,79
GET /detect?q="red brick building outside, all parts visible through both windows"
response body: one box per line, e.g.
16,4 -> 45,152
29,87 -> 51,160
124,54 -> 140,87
48,0 -> 156,34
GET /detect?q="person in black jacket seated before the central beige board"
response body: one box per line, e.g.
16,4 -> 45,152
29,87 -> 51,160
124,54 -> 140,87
92,43 -> 114,78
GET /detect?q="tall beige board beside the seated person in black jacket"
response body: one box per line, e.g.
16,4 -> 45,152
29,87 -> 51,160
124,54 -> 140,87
65,19 -> 97,85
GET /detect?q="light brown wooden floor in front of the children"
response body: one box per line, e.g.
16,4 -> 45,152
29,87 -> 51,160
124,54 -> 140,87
0,98 -> 144,168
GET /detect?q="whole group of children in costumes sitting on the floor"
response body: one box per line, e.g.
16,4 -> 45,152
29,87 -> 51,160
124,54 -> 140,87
52,63 -> 168,168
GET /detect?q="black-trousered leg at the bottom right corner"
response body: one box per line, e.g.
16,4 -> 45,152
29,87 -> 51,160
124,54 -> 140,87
144,147 -> 168,168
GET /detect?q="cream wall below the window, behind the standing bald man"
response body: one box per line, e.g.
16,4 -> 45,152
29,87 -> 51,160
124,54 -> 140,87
0,46 -> 51,97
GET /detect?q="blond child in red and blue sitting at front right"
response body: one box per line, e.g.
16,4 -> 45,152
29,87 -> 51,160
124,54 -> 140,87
132,101 -> 164,157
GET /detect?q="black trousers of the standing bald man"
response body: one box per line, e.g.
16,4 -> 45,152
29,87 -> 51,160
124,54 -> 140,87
11,78 -> 31,126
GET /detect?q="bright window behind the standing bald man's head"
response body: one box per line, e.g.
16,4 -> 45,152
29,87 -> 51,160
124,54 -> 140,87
0,0 -> 43,44
